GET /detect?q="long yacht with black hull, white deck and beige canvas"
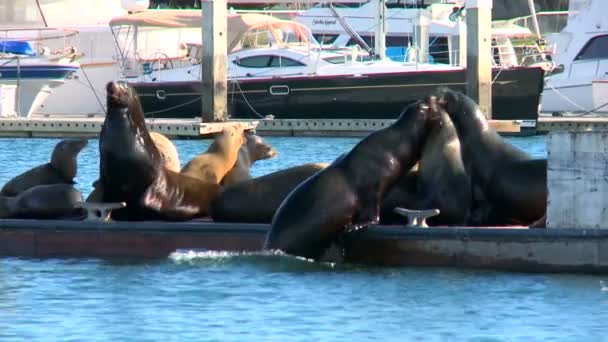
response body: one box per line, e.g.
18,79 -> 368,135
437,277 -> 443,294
115,10 -> 544,126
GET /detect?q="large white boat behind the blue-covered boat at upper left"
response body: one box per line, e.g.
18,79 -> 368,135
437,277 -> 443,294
11,0 -> 136,117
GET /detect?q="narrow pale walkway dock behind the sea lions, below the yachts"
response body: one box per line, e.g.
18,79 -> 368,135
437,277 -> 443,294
0,115 -> 608,139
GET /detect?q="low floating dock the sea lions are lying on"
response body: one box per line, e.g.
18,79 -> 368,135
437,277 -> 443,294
0,219 -> 608,274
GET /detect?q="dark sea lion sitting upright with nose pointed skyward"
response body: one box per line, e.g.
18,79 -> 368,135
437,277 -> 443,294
99,82 -> 220,220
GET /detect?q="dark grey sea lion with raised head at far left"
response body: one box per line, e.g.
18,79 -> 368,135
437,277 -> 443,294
0,139 -> 88,196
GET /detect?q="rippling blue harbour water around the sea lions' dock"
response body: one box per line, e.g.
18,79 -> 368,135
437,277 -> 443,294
0,137 -> 608,341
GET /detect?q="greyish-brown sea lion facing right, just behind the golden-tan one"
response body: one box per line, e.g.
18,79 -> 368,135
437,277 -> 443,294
221,134 -> 278,186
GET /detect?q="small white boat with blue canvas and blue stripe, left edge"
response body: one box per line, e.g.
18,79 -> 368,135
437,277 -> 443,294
0,35 -> 79,117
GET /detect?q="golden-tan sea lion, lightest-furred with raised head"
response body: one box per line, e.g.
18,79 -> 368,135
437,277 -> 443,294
181,125 -> 245,184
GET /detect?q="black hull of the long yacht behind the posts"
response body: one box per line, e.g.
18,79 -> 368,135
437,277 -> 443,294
131,68 -> 544,121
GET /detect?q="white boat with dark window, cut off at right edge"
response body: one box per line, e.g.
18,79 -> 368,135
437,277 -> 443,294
541,0 -> 608,115
